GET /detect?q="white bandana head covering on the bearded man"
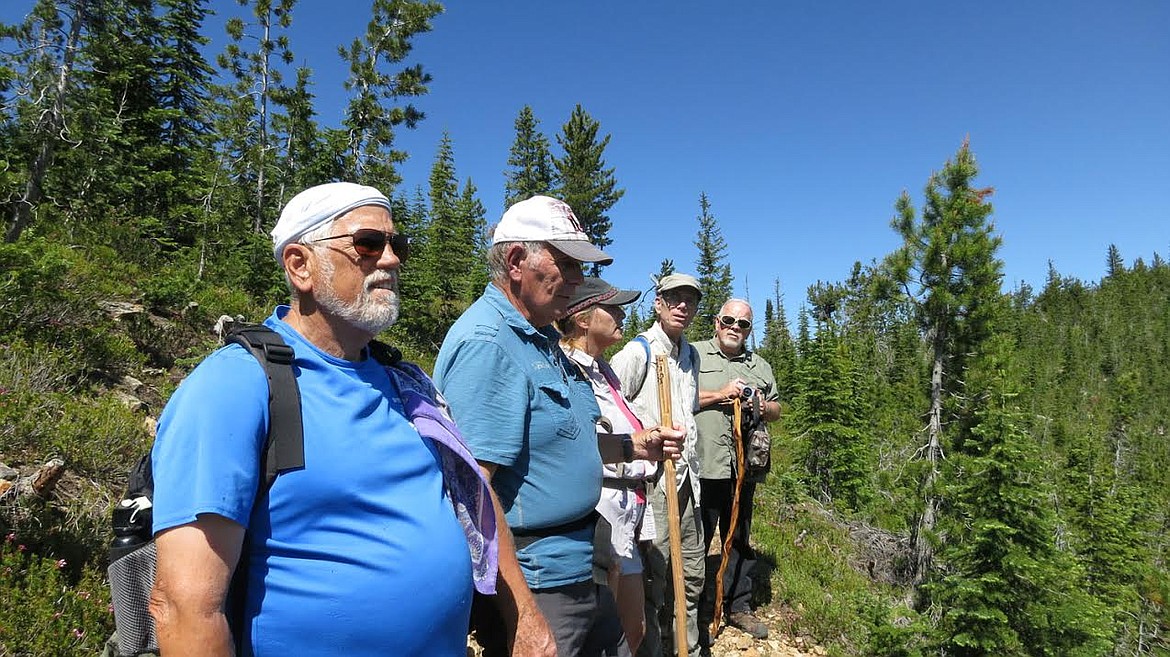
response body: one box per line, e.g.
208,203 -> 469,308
273,182 -> 390,262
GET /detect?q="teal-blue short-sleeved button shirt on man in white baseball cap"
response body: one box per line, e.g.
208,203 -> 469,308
434,284 -> 601,589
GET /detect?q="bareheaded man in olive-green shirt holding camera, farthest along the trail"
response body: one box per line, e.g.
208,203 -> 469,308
695,299 -> 780,638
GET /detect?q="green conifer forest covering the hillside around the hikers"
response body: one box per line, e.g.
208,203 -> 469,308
0,0 -> 1170,657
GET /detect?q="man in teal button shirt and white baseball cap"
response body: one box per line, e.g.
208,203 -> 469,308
435,196 -> 683,657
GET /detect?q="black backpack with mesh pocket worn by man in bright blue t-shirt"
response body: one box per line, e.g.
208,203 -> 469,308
103,324 -> 304,657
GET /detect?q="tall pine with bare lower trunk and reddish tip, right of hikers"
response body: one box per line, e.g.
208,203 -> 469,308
887,141 -> 1002,583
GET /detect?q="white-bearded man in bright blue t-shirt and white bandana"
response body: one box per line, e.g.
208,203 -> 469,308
151,182 -> 496,657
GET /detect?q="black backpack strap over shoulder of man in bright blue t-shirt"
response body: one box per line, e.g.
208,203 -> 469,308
223,324 -> 304,489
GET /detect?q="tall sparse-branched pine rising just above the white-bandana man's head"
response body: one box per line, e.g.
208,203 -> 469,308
338,0 -> 442,189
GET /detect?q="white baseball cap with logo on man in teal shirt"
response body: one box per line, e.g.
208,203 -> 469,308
491,196 -> 613,264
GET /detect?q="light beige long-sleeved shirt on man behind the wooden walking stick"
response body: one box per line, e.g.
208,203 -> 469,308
610,323 -> 700,500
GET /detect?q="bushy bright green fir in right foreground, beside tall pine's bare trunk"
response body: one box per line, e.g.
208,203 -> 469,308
932,337 -> 1108,656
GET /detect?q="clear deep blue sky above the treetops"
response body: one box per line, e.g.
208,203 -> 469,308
0,0 -> 1170,319
